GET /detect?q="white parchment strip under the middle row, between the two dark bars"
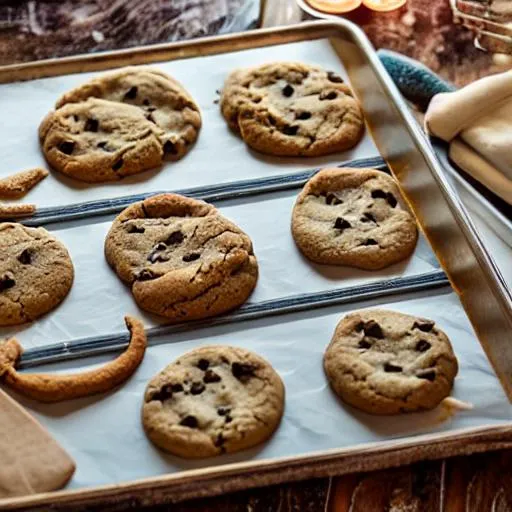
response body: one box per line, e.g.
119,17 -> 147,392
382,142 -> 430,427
0,189 -> 439,348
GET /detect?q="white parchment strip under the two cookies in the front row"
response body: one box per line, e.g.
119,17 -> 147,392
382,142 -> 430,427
10,291 -> 512,488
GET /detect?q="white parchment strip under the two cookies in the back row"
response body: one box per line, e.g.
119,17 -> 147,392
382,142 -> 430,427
0,40 -> 378,207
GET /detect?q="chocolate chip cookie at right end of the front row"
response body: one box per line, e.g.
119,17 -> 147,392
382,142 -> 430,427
324,310 -> 458,414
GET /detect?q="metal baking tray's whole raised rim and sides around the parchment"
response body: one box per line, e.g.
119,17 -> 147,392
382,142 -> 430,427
0,20 -> 512,511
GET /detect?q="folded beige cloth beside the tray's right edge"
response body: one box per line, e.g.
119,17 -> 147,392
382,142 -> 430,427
425,71 -> 512,204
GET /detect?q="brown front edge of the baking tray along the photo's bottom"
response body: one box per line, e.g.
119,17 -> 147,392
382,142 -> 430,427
4,424 -> 512,512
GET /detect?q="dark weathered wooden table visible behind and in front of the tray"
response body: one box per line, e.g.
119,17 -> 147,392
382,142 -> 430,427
0,0 -> 512,512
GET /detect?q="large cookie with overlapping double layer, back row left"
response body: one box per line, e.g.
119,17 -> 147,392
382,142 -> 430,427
39,67 -> 201,182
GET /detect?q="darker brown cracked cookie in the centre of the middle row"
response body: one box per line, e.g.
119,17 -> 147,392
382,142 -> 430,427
105,194 -> 258,322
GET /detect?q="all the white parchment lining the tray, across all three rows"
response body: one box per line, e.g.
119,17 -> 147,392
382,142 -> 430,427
0,41 -> 506,494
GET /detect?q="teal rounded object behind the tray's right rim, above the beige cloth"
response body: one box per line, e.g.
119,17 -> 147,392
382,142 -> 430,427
377,50 -> 457,111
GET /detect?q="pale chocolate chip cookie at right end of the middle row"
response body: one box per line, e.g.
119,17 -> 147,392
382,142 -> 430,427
292,169 -> 418,270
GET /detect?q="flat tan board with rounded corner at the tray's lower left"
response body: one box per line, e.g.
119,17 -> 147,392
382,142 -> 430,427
0,390 -> 75,500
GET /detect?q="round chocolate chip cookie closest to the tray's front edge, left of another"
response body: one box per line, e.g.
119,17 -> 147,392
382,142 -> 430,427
142,345 -> 284,458
